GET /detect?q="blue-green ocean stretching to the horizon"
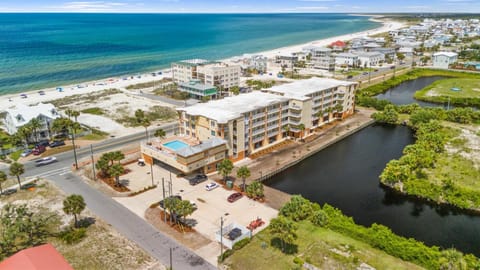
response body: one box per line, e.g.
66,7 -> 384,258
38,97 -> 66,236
0,13 -> 379,94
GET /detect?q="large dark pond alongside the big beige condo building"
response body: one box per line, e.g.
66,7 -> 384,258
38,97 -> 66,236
266,125 -> 480,256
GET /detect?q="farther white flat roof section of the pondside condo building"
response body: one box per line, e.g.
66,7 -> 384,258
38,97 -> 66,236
265,77 -> 357,100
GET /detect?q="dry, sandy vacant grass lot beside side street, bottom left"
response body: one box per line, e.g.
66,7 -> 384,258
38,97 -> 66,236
0,180 -> 165,270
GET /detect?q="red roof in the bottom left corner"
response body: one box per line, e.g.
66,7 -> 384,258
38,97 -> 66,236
0,244 -> 73,270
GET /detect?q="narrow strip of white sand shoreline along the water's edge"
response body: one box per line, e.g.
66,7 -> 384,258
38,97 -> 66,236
0,16 -> 405,111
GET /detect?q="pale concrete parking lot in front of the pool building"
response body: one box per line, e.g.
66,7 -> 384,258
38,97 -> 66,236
114,164 -> 278,261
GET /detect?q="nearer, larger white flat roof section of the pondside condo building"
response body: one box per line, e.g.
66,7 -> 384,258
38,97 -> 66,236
177,91 -> 289,124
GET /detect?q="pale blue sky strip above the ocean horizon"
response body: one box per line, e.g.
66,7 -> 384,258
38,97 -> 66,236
0,0 -> 480,13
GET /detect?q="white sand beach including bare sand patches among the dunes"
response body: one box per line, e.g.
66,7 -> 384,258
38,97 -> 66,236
0,16 -> 405,135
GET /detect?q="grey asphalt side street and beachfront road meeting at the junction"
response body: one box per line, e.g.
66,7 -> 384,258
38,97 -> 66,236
1,123 -> 216,269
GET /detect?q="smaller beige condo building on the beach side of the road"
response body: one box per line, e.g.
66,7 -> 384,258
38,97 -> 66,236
172,59 -> 240,89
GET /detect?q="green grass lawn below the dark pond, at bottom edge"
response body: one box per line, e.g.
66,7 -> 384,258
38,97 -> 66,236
225,221 -> 422,269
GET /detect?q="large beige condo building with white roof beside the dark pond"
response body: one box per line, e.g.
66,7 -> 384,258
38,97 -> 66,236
177,78 -> 357,160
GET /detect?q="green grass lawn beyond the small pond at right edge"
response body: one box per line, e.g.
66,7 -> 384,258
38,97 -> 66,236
415,78 -> 480,98
